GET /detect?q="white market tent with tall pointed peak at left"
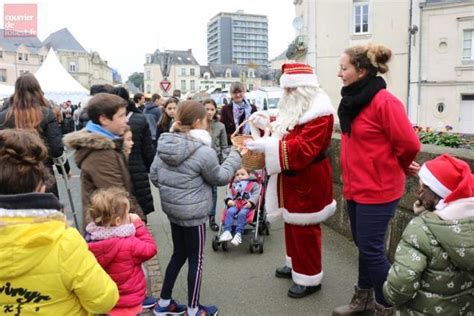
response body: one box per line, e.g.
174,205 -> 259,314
35,49 -> 89,104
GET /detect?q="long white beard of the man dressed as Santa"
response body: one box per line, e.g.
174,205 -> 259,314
272,87 -> 318,136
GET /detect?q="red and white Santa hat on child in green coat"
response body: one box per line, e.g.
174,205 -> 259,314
418,154 -> 474,203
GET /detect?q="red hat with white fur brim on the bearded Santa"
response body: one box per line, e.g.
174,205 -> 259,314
280,63 -> 319,88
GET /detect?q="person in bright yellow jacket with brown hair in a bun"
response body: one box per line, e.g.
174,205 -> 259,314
0,129 -> 118,316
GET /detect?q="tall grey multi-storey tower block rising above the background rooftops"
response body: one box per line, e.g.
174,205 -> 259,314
207,10 -> 268,67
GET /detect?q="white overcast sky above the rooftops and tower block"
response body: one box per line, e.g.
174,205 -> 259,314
0,0 -> 295,80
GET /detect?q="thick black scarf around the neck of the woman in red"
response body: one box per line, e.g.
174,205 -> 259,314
337,75 -> 387,135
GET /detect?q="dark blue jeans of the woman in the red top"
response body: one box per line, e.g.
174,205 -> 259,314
347,200 -> 399,306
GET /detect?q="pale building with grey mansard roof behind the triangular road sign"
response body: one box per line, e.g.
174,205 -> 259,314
144,49 -> 200,95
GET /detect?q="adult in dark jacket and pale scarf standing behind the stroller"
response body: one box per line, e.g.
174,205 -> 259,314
221,82 -> 257,145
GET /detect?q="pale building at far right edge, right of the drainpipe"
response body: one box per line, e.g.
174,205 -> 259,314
412,0 -> 474,134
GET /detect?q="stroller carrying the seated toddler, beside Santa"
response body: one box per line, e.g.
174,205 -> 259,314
212,169 -> 270,253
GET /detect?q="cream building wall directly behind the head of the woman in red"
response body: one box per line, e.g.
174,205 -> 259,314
287,0 -> 410,119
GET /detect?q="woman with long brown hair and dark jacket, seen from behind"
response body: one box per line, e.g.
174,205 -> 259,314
0,73 -> 70,197
